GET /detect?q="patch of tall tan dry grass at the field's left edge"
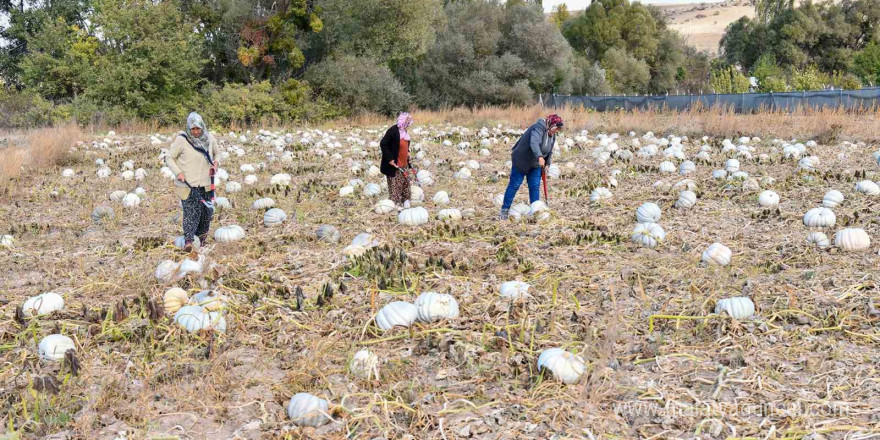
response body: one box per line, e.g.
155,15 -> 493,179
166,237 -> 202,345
0,124 -> 82,194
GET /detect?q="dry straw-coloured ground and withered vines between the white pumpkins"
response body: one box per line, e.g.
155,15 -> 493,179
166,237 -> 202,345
0,117 -> 880,440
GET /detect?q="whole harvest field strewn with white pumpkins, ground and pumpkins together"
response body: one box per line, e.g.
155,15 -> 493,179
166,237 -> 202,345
0,117 -> 880,440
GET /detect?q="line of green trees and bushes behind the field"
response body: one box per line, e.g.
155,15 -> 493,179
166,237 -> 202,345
0,0 -> 880,126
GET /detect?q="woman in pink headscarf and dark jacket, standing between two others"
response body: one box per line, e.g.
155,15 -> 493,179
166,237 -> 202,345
379,112 -> 413,206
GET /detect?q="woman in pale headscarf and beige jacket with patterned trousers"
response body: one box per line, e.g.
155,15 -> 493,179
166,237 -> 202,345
165,112 -> 220,252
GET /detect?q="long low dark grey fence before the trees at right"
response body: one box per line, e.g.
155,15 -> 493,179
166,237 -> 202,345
542,87 -> 880,113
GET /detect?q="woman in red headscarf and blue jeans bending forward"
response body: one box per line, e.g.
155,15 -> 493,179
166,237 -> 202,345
499,114 -> 563,220
